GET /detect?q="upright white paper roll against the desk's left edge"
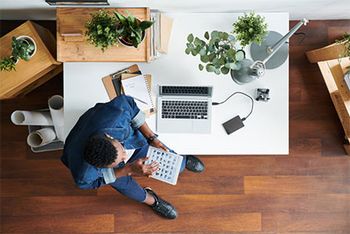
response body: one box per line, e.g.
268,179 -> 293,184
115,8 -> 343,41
48,95 -> 65,142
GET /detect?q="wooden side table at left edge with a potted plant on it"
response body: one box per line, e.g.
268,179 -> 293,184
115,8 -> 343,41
0,21 -> 62,99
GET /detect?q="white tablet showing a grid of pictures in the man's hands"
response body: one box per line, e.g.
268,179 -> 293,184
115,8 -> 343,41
145,146 -> 183,185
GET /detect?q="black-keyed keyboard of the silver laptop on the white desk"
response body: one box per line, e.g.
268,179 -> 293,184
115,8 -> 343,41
161,101 -> 208,119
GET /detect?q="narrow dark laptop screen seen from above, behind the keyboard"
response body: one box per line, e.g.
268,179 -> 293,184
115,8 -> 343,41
160,86 -> 210,96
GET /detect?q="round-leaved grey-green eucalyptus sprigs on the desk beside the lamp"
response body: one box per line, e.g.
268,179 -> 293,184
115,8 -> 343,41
185,31 -> 245,75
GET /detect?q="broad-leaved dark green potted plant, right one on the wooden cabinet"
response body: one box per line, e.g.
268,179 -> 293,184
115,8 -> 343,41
114,12 -> 154,48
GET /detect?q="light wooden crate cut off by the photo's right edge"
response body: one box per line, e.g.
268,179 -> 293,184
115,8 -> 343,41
317,57 -> 350,155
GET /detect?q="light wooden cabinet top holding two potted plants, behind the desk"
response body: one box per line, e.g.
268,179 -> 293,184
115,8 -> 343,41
56,8 -> 150,62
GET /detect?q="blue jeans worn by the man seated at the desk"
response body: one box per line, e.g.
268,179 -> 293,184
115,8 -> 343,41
110,144 -> 186,202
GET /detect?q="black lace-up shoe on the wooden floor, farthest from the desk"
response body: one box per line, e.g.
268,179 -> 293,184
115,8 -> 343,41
145,187 -> 177,219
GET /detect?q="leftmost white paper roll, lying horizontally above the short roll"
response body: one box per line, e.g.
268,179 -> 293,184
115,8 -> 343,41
11,110 -> 53,126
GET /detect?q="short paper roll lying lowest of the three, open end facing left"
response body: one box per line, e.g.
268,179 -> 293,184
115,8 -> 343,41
27,128 -> 56,147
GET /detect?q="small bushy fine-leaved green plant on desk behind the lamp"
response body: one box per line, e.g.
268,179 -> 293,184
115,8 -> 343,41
232,12 -> 267,46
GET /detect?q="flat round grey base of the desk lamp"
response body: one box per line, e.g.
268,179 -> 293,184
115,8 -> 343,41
250,31 -> 289,69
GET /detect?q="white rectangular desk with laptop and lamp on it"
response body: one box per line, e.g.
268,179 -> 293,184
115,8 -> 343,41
64,13 -> 289,155
